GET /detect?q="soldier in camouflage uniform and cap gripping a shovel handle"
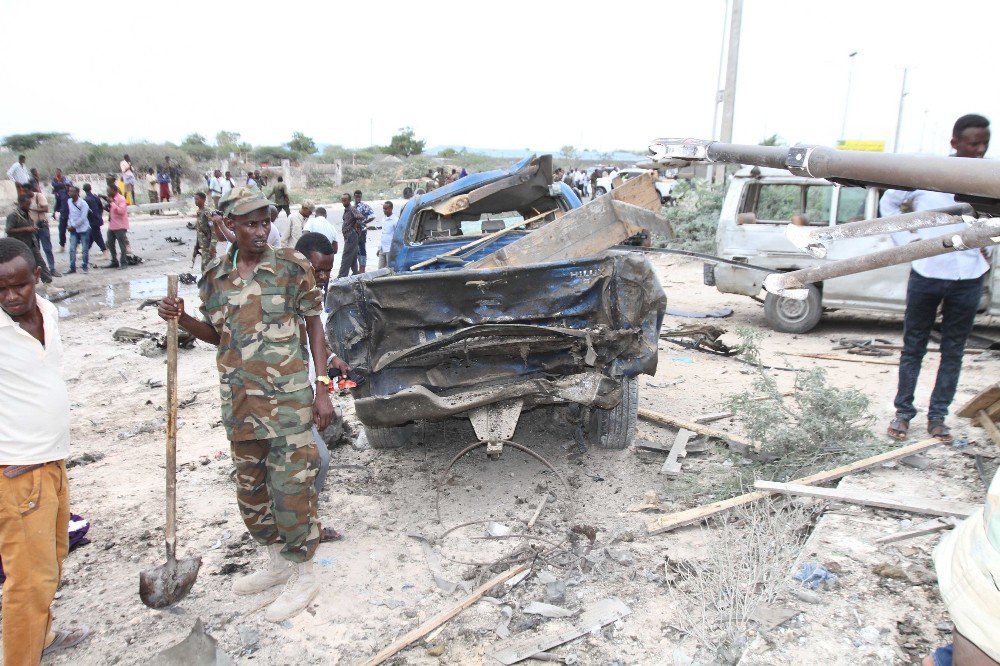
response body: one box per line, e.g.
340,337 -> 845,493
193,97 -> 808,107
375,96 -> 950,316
159,187 -> 333,622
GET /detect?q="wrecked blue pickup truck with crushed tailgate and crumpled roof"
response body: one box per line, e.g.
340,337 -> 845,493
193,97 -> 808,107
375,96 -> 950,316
327,155 -> 666,448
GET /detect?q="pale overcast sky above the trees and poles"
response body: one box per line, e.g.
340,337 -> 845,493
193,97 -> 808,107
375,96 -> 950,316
0,0 -> 1000,154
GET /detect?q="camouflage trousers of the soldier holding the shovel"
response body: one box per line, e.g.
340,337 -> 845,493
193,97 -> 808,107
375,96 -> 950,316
230,430 -> 320,562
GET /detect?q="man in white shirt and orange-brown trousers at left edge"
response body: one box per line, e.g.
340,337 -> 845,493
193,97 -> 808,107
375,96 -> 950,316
0,238 -> 90,664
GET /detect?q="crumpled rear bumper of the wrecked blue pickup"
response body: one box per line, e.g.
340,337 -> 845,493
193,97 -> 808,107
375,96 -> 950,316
354,372 -> 622,428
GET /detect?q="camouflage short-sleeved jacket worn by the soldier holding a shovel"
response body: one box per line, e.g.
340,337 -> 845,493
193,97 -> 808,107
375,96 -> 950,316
198,247 -> 323,442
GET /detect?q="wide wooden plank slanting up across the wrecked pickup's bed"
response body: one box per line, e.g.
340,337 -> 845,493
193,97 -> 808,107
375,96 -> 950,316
466,174 -> 667,269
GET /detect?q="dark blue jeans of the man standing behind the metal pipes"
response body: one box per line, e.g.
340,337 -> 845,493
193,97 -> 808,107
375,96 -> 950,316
894,271 -> 983,421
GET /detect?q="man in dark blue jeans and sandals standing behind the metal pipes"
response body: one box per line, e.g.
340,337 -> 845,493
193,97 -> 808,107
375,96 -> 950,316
879,114 -> 990,442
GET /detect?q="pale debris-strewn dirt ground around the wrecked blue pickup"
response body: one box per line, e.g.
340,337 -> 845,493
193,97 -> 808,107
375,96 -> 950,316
27,208 -> 1000,664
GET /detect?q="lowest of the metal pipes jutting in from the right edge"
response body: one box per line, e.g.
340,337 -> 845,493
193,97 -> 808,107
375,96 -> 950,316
764,218 -> 1000,300
